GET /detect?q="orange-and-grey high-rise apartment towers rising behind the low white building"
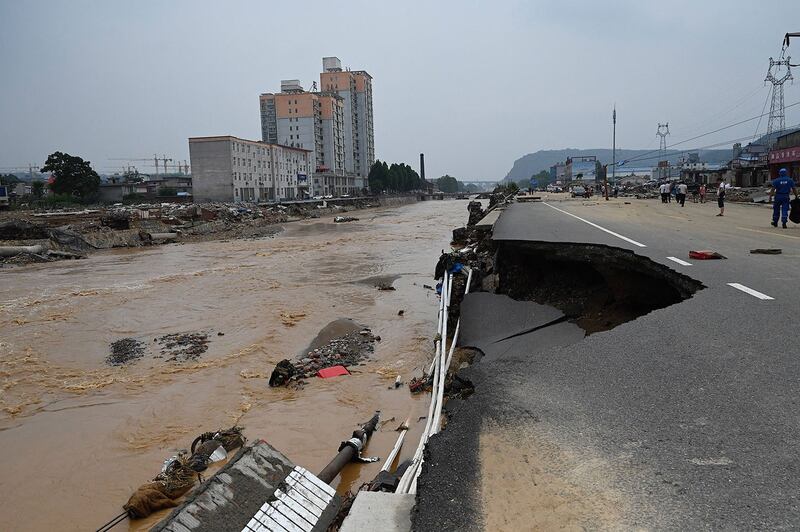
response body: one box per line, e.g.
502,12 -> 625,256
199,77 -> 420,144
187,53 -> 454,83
259,57 -> 375,182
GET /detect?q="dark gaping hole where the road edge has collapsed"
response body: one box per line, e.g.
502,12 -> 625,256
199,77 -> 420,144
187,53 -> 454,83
495,241 -> 705,334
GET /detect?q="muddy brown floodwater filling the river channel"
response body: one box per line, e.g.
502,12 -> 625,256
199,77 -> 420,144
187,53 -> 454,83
0,201 -> 467,530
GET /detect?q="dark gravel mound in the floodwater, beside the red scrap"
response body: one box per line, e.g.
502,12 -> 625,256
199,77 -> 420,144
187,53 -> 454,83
269,329 -> 381,387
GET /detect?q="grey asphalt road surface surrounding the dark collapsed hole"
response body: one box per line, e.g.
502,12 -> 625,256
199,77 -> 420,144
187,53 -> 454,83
413,200 -> 800,530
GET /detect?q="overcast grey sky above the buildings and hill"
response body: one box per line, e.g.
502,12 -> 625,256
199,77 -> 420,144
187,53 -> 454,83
0,0 -> 800,179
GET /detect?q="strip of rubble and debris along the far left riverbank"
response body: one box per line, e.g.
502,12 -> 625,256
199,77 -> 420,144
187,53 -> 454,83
0,195 -> 419,267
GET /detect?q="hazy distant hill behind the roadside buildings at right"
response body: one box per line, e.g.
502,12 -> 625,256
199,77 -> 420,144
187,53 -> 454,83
505,148 -> 733,181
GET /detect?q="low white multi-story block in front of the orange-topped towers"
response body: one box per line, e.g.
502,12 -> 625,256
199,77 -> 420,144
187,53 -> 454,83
189,135 -> 313,202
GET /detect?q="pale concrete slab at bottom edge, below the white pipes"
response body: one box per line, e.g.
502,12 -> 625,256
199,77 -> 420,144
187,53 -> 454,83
340,491 -> 414,532
